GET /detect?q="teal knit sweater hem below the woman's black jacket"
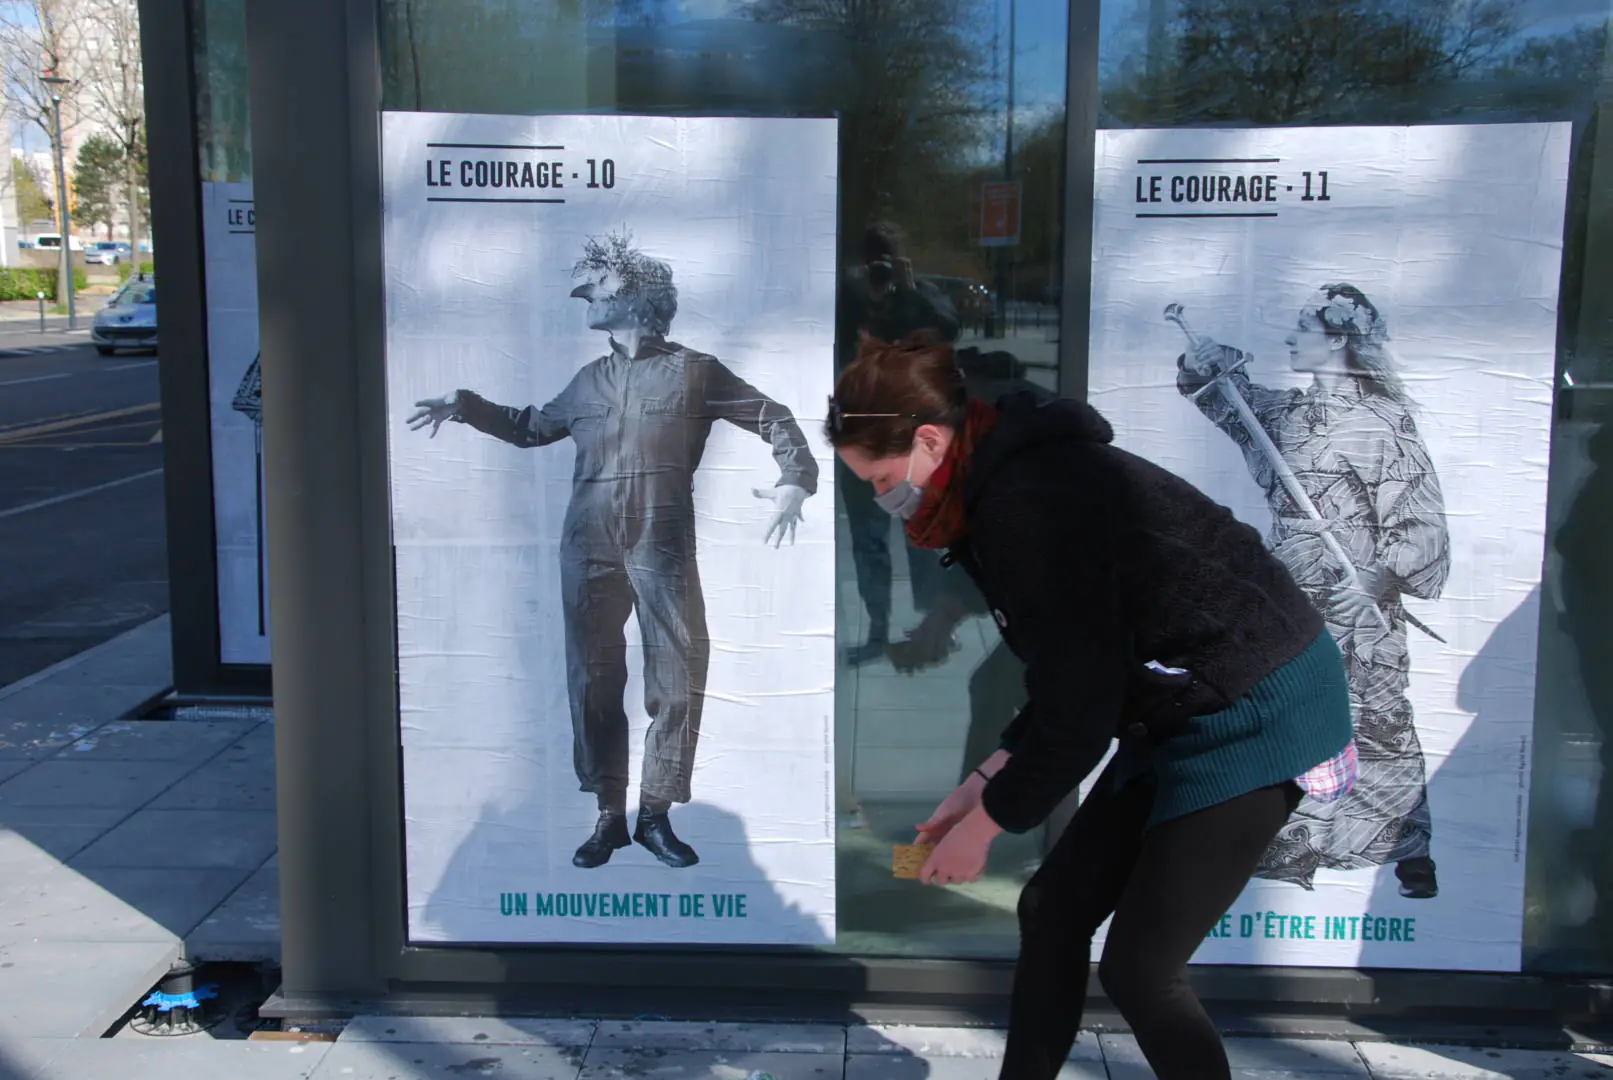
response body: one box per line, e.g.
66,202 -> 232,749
1098,630 -> 1352,827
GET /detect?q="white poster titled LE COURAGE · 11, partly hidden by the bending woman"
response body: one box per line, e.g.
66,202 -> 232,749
1090,124 -> 1569,970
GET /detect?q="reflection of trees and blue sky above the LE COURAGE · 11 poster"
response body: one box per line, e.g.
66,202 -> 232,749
1100,0 -> 1608,127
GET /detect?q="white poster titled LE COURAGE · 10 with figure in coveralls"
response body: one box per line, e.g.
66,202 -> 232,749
382,113 -> 837,945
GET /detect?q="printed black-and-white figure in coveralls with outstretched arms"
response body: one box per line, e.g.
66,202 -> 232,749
408,234 -> 818,867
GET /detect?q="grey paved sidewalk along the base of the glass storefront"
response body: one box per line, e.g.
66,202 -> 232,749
0,617 -> 1613,1080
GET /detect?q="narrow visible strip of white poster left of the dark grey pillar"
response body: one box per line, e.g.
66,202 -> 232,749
202,182 -> 269,664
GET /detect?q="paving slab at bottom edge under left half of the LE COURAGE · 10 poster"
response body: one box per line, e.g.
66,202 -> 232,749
306,1040 -> 580,1080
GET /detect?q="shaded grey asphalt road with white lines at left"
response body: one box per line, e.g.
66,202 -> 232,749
0,326 -> 168,687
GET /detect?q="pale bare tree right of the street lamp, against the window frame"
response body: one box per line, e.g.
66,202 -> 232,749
79,0 -> 145,249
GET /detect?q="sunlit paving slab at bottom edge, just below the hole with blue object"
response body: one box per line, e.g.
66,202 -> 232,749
24,1036 -> 333,1080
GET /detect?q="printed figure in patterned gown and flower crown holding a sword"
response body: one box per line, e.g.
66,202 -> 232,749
1177,285 -> 1450,898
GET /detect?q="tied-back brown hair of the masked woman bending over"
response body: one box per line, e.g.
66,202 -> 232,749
826,330 -> 968,461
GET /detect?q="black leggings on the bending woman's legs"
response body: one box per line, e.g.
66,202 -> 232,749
1002,775 -> 1300,1080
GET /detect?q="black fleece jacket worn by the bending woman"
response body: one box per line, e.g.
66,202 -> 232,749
950,395 -> 1324,832
